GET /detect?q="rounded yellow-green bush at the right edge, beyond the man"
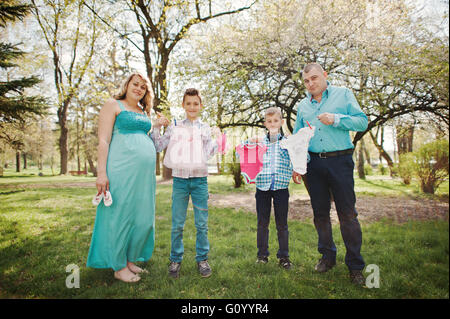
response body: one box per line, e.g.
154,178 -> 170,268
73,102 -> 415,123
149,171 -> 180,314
413,140 -> 449,194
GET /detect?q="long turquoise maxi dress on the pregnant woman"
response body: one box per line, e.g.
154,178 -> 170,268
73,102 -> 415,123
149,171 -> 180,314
87,101 -> 156,271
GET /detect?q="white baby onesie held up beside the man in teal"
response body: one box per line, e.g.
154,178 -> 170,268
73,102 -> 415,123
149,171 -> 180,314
280,126 -> 316,175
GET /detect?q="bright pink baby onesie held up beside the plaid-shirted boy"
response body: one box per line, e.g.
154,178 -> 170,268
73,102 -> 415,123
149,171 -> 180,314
236,143 -> 267,184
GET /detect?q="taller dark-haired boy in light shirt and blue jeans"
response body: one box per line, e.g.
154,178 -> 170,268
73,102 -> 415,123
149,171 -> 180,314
151,89 -> 220,278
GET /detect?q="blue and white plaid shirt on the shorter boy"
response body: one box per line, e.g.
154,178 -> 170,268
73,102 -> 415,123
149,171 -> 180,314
256,135 -> 292,191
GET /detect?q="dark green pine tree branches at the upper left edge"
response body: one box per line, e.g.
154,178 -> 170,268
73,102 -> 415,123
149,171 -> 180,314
0,0 -> 46,128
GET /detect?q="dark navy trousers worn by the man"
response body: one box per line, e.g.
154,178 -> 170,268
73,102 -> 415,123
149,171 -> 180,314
306,154 -> 365,270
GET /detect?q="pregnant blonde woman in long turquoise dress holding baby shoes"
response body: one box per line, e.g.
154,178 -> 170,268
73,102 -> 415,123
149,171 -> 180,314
87,73 -> 156,282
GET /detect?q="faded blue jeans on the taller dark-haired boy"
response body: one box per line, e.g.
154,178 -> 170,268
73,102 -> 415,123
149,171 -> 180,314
170,177 -> 209,263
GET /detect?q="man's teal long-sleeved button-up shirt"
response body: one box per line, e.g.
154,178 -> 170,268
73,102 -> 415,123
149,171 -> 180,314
293,83 -> 368,153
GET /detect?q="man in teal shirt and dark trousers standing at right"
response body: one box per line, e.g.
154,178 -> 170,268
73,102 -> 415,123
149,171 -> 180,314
292,63 -> 367,285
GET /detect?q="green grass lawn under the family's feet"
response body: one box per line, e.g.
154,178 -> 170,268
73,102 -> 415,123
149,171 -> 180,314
0,170 -> 449,299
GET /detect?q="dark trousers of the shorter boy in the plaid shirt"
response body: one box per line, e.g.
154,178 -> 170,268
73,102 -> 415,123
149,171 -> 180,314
255,188 -> 289,258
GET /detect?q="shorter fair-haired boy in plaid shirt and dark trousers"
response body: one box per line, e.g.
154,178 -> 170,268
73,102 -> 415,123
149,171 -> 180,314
251,107 -> 292,269
